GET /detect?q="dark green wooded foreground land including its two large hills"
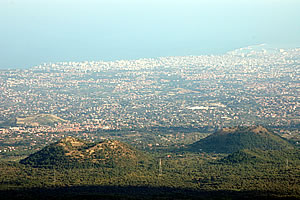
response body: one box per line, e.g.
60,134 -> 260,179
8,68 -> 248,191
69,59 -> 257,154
0,127 -> 300,199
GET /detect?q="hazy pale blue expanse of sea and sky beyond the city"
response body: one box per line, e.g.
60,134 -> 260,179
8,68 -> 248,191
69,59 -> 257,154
0,0 -> 300,69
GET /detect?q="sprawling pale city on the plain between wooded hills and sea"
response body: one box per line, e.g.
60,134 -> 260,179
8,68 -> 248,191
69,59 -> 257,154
0,45 -> 300,152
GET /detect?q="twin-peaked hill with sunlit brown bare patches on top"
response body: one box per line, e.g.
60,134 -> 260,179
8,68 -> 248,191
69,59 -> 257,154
20,137 -> 151,168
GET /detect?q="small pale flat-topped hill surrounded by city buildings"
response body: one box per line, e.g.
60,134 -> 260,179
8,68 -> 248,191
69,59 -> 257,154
16,114 -> 67,126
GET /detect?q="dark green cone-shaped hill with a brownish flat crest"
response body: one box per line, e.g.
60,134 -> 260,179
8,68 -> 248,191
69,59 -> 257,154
188,126 -> 293,153
